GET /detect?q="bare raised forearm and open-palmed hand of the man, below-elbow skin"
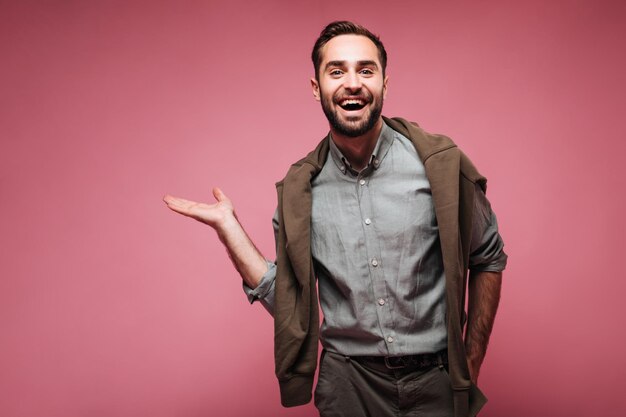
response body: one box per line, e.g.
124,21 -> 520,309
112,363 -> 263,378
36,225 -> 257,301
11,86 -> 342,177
163,188 -> 268,288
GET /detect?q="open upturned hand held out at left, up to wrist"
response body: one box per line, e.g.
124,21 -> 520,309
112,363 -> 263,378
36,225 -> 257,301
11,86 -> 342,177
163,187 -> 235,230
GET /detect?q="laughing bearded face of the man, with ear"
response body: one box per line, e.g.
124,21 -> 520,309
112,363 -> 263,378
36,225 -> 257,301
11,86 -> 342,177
311,35 -> 387,137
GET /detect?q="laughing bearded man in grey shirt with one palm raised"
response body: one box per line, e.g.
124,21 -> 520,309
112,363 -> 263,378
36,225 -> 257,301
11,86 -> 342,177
165,22 -> 506,416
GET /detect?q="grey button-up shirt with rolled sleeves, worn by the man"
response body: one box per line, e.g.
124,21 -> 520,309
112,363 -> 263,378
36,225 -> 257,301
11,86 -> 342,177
244,125 -> 507,356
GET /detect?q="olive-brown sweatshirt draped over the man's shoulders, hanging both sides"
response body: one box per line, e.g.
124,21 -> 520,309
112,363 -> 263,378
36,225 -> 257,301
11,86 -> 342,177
274,117 -> 486,417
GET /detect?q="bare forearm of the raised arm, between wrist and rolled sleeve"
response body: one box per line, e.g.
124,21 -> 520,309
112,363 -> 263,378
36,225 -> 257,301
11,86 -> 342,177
215,214 -> 267,289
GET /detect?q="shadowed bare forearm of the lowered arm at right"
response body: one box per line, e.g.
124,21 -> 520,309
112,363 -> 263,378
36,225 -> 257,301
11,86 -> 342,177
465,272 -> 502,382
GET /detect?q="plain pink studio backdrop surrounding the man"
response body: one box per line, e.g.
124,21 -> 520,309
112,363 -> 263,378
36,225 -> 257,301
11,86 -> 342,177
0,0 -> 626,417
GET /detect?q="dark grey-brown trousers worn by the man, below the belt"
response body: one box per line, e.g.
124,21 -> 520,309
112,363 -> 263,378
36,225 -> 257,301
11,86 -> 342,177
315,351 -> 454,417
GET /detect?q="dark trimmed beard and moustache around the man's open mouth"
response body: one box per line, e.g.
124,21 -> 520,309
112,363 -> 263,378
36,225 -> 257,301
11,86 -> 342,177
320,90 -> 383,138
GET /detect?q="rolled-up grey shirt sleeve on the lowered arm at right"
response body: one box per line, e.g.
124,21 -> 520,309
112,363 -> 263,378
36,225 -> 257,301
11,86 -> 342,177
469,184 -> 508,272
